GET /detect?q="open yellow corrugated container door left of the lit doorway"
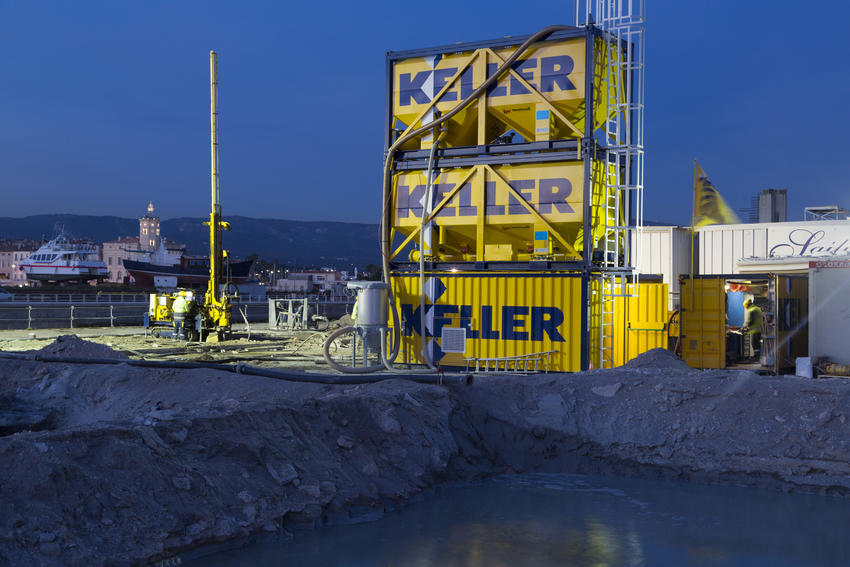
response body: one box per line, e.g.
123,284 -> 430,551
681,278 -> 726,368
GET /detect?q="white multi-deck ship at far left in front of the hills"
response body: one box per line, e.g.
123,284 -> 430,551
20,234 -> 109,282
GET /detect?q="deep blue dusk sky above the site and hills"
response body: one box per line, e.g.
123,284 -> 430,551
0,0 -> 850,224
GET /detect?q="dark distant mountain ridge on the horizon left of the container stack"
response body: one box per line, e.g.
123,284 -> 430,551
0,214 -> 380,269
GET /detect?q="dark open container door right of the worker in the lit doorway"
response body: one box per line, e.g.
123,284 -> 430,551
762,275 -> 809,375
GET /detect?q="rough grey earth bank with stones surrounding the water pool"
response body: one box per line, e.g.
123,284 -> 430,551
0,338 -> 850,565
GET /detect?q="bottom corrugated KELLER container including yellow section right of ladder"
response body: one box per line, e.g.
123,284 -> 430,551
392,272 -> 667,372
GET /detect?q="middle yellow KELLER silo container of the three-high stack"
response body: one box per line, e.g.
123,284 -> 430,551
390,160 -> 618,262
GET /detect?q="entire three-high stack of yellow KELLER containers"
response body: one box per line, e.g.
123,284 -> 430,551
382,13 -> 666,371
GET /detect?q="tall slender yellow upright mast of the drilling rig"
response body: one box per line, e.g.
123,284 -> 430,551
203,51 -> 231,340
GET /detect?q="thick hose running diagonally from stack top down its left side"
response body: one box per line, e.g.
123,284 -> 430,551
380,25 -> 574,361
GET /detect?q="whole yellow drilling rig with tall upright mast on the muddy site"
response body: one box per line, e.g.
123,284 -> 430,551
145,51 -> 235,342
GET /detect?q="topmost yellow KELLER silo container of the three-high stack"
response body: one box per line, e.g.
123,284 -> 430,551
390,30 -> 620,149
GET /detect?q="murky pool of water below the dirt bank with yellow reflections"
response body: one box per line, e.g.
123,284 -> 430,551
187,475 -> 850,567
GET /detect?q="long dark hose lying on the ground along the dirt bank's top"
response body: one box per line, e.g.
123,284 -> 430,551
0,352 -> 473,386
